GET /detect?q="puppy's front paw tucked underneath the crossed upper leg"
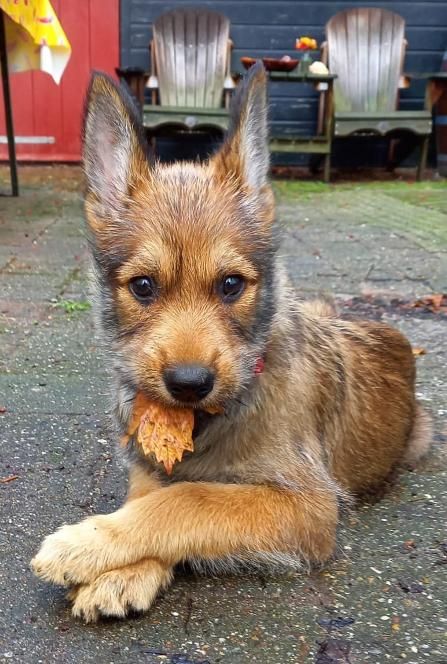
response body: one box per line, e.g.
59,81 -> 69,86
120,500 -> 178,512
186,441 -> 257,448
68,560 -> 172,622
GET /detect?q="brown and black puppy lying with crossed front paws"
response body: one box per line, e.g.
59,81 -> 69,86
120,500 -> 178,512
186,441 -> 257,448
32,65 -> 430,621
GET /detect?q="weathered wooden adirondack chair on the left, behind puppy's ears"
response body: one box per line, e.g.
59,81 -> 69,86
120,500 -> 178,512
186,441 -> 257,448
143,9 -> 235,135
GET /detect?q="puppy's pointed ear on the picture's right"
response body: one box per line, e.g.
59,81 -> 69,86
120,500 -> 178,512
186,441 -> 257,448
214,62 -> 270,189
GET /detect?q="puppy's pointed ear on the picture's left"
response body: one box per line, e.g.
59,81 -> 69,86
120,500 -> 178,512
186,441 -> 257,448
83,73 -> 148,214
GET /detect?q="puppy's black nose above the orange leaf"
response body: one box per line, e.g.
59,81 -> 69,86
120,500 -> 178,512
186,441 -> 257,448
163,364 -> 214,401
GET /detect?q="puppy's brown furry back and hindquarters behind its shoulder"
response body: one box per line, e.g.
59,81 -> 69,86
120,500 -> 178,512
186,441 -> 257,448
294,301 -> 431,494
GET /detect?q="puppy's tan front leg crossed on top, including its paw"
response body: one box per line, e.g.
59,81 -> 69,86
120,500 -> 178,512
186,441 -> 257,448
32,482 -> 337,585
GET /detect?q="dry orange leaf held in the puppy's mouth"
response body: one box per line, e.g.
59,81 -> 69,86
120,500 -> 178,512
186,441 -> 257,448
121,392 -> 194,475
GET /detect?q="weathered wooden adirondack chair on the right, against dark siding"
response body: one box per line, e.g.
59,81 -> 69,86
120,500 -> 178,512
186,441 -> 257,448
322,8 -> 432,180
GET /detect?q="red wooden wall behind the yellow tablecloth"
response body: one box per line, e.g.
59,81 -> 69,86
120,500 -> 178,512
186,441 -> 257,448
0,0 -> 119,161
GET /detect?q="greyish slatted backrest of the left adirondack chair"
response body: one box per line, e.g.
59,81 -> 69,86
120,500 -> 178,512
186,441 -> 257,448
153,9 -> 230,108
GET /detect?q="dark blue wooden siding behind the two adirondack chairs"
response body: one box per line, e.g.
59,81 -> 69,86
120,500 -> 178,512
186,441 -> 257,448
121,0 -> 447,163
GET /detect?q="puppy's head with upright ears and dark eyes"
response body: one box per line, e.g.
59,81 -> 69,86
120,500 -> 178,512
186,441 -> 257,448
84,65 -> 274,408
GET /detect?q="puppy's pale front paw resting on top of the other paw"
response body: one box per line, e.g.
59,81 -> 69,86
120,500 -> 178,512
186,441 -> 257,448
31,516 -> 122,586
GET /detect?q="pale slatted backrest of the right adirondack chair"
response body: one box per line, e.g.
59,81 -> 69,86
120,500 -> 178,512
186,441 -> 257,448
326,8 -> 405,112
